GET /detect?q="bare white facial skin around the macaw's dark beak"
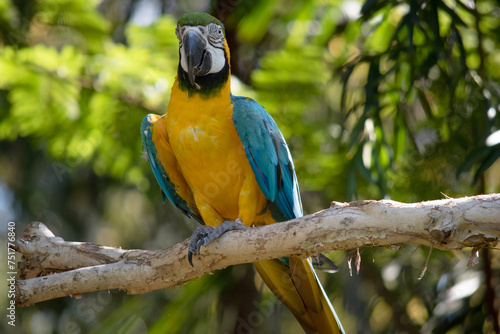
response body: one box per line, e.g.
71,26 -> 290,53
178,23 -> 226,74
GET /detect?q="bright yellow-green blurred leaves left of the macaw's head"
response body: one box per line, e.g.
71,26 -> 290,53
0,14 -> 177,187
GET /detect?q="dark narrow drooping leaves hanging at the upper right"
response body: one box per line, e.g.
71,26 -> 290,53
340,0 -> 499,195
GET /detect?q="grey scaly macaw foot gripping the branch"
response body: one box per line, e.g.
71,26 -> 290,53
188,218 -> 249,267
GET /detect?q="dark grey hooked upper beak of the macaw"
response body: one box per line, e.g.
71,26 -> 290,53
183,30 -> 212,89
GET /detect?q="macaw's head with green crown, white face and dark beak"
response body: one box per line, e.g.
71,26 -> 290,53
175,13 -> 230,91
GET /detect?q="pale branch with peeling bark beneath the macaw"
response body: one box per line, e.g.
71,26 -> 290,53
10,194 -> 500,306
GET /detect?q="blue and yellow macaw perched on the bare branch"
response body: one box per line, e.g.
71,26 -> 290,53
141,13 -> 344,333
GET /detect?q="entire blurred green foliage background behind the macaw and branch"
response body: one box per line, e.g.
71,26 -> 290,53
0,0 -> 500,333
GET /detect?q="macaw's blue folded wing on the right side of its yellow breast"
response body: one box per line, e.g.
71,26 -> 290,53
231,96 -> 302,219
